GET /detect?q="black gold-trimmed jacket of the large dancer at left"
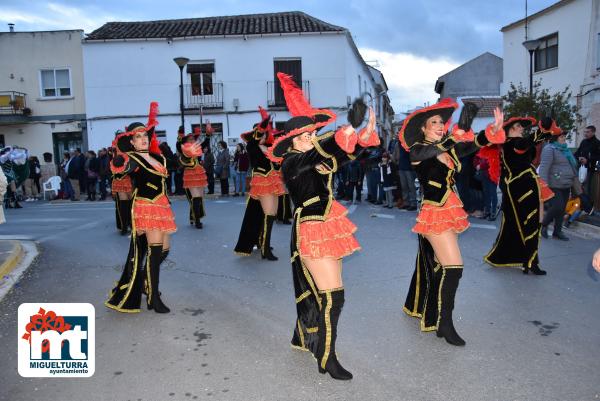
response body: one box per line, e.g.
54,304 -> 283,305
113,152 -> 167,202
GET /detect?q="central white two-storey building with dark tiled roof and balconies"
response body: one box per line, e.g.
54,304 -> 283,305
83,12 -> 389,149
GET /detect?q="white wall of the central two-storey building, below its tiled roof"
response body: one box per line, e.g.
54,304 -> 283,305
83,34 -> 371,149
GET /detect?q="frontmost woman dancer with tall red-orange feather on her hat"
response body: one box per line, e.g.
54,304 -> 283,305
269,73 -> 379,380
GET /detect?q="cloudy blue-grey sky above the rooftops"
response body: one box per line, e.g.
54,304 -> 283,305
0,0 -> 555,112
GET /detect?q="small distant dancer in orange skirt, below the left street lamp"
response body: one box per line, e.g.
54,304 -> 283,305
177,127 -> 208,229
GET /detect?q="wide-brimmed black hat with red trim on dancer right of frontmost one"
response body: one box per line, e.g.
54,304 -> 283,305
398,98 -> 458,151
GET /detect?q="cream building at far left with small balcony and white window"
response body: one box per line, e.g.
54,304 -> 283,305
0,24 -> 86,162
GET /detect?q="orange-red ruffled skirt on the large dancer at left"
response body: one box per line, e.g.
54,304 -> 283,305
132,195 -> 177,233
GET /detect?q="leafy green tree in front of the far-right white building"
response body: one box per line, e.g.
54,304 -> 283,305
502,81 -> 581,131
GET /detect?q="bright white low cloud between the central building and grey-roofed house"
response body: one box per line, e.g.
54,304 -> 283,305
359,48 -> 459,113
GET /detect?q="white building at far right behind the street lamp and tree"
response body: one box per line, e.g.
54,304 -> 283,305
501,0 -> 600,138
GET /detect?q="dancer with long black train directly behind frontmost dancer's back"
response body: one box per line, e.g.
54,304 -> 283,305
235,107 -> 285,261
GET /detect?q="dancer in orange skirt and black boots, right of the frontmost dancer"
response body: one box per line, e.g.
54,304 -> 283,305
399,99 -> 505,345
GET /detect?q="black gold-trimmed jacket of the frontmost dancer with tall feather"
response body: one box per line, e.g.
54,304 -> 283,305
281,131 -> 363,222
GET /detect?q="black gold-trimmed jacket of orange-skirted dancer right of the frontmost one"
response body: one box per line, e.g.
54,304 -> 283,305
410,133 -> 489,206
